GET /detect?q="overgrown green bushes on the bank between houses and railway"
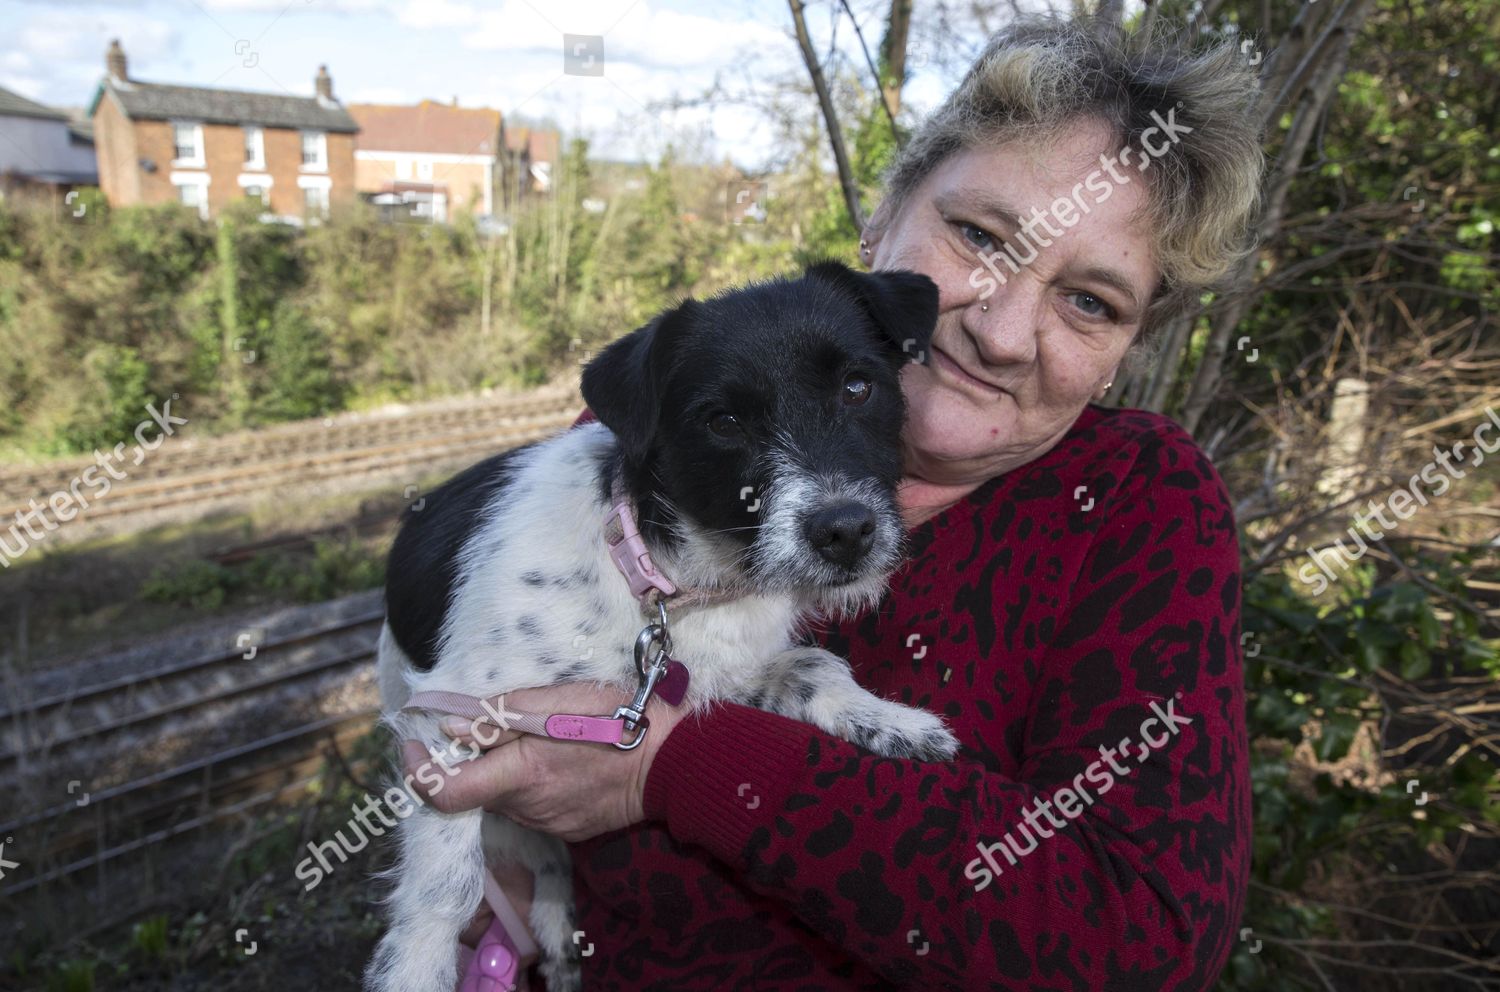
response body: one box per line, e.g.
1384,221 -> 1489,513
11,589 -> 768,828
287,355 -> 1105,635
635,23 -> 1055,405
0,159 -> 822,453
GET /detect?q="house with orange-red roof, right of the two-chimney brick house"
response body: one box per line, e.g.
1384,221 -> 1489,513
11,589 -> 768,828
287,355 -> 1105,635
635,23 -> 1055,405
350,99 -> 506,221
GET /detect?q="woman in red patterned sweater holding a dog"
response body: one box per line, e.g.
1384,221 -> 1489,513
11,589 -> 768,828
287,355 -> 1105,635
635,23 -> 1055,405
408,21 -> 1262,990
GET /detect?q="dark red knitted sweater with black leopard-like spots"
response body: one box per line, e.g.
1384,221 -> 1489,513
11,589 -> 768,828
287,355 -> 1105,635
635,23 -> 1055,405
573,407 -> 1250,992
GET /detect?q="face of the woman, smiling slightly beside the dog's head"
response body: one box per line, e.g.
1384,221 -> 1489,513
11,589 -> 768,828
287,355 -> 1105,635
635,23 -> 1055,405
867,122 -> 1160,485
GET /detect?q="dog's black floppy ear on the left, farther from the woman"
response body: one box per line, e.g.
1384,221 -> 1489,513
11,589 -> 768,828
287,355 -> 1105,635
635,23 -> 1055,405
582,300 -> 698,461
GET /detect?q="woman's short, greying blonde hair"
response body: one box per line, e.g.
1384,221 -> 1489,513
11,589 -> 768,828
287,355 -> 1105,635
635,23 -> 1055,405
878,18 -> 1265,344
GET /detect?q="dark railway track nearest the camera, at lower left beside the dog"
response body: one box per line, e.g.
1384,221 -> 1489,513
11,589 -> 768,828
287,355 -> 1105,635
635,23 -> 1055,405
0,594 -> 383,926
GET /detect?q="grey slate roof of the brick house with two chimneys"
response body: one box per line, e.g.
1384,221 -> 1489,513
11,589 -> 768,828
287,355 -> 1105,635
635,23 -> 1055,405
89,77 -> 359,132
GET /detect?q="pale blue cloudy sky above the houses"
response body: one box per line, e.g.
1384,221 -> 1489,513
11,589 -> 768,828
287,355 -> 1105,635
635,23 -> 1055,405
0,0 -> 983,168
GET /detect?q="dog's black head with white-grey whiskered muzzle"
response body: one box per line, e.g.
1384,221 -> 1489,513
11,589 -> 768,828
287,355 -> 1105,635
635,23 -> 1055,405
584,263 -> 938,608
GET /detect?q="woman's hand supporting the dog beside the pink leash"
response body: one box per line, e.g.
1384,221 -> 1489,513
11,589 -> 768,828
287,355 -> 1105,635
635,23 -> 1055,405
402,683 -> 683,842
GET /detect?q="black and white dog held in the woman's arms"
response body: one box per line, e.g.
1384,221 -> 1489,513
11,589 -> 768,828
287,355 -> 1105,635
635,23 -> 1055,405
365,263 -> 957,992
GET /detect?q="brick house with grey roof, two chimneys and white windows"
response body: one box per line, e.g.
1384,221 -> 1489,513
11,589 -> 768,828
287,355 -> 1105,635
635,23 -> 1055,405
89,41 -> 359,219
